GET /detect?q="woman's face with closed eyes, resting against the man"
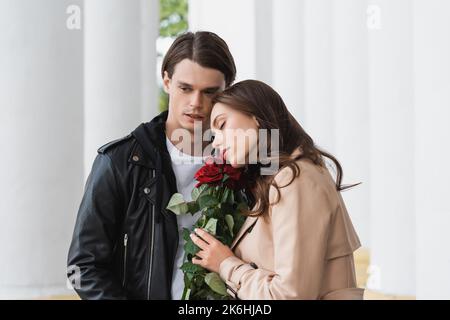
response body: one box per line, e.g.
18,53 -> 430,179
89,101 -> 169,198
211,102 -> 258,168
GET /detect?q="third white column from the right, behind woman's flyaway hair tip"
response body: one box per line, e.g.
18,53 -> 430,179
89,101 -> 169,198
332,0 -> 370,247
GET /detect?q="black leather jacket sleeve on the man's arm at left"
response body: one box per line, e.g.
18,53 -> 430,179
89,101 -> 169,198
67,154 -> 125,299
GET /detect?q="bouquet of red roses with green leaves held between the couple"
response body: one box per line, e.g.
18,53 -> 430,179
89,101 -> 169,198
167,158 -> 248,300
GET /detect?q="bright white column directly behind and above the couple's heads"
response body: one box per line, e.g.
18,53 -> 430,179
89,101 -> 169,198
189,0 -> 272,84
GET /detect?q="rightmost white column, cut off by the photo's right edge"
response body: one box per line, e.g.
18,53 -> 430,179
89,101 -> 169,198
412,0 -> 450,299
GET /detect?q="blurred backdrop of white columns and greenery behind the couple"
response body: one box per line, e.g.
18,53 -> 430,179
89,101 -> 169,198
0,0 -> 450,299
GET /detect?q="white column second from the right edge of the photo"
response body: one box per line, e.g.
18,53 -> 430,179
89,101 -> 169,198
368,0 -> 415,295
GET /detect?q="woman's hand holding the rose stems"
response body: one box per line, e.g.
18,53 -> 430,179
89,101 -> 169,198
191,228 -> 234,273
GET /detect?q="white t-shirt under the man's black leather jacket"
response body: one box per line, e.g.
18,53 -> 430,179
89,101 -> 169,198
166,137 -> 205,300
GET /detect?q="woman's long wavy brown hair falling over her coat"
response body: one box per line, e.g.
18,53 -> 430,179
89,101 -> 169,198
212,80 -> 354,216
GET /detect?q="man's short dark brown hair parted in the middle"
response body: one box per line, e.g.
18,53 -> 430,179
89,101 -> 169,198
161,31 -> 236,87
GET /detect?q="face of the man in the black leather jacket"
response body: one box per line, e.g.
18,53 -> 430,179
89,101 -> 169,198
163,59 -> 225,133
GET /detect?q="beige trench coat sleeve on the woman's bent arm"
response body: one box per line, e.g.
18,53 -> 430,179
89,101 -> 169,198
220,168 -> 333,300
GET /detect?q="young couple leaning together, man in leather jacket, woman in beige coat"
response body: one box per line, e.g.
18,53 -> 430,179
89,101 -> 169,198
68,32 -> 363,299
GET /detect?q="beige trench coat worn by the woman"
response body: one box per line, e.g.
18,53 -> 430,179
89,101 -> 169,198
220,159 -> 364,299
